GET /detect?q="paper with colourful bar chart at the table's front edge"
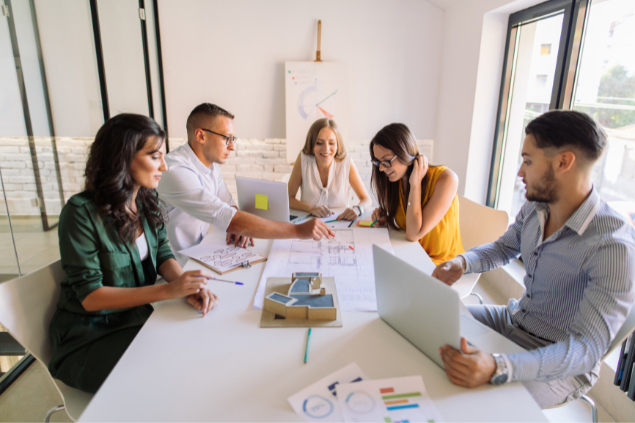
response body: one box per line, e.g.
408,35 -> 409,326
337,376 -> 443,423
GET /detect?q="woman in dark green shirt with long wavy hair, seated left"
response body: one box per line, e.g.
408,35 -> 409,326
49,114 -> 217,392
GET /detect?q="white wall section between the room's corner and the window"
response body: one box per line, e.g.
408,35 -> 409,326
434,0 -> 544,203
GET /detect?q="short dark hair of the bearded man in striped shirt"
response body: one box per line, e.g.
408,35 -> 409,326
525,110 -> 606,162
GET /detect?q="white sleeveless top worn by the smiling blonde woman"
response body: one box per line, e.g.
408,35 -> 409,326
300,153 -> 352,208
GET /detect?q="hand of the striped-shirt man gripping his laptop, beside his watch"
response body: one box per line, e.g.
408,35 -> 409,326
439,338 -> 496,388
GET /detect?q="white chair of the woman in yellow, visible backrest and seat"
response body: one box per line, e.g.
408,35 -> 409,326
452,196 -> 509,304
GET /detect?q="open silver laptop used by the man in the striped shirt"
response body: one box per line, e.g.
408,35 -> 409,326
373,245 -> 525,367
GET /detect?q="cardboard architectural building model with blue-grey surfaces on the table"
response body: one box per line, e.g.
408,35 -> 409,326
263,272 -> 337,320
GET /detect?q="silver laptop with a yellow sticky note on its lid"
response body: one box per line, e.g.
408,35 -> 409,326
236,176 -> 298,222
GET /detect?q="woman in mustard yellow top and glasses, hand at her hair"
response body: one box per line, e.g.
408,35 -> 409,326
370,123 -> 465,264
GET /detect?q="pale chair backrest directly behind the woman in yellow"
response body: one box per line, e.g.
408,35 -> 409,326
459,196 -> 509,250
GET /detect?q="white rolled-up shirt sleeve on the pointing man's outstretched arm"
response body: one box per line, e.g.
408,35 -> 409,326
157,165 -> 236,232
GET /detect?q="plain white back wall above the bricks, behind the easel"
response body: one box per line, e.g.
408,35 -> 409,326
159,0 -> 444,140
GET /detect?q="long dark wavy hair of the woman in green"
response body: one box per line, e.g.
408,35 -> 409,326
84,113 -> 165,243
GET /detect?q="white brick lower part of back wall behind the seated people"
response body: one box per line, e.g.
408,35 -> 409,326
0,137 -> 434,215
